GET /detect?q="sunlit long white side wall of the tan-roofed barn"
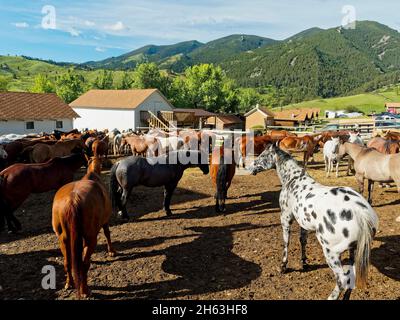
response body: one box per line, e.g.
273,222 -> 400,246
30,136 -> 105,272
73,107 -> 135,130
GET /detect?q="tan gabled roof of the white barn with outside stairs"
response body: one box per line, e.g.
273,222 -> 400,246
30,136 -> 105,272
70,89 -> 172,109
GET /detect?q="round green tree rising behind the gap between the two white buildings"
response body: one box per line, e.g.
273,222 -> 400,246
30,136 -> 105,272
56,70 -> 85,103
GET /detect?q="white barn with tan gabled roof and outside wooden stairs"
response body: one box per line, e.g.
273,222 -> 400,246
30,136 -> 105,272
70,89 -> 173,131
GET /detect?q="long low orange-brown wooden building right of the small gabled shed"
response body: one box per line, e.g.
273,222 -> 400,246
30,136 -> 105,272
274,108 -> 320,127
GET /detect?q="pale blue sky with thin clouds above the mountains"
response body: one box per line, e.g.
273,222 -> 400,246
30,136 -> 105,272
0,0 -> 400,62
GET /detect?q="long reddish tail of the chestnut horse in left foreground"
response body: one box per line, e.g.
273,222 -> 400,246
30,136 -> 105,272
64,194 -> 83,296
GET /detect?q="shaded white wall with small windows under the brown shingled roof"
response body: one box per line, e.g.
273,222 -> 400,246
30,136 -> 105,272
0,119 -> 73,135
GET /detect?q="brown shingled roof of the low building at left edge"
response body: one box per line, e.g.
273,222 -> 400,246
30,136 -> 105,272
0,92 -> 79,120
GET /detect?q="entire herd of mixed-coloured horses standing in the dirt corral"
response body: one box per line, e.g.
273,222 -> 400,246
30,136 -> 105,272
0,125 -> 400,299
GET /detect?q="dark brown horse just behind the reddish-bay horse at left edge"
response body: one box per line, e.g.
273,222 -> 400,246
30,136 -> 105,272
23,139 -> 85,163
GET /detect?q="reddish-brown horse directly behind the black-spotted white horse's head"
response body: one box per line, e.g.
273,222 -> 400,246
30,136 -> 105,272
236,135 -> 273,168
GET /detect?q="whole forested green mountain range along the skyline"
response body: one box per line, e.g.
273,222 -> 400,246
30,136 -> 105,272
0,21 -> 400,101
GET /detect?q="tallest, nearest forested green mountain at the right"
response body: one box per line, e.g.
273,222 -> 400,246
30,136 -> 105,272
222,21 -> 400,101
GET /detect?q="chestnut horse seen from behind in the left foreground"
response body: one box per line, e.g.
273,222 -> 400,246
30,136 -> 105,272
52,157 -> 116,298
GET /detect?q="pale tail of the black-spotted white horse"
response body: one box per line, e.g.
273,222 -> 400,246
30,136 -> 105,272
355,207 -> 378,288
